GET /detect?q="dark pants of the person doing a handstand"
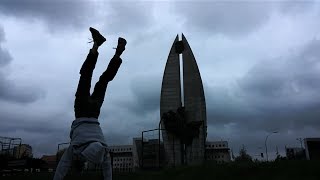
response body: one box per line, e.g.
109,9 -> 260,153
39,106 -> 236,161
74,50 -> 122,119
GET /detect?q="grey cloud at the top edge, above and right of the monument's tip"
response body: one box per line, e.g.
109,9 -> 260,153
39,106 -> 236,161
174,1 -> 314,38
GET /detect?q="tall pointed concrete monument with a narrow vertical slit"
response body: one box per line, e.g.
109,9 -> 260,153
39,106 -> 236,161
160,34 -> 207,166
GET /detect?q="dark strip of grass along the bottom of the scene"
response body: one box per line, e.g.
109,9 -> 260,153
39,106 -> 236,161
0,161 -> 320,180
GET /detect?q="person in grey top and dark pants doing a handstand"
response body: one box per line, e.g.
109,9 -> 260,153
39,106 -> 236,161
54,27 -> 127,180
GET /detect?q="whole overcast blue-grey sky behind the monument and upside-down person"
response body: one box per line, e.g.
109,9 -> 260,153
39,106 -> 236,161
0,0 -> 320,160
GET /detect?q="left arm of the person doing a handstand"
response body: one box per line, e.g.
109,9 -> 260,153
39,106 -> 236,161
53,146 -> 73,180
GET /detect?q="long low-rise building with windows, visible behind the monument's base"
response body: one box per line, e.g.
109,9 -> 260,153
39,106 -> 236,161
66,137 -> 231,173
